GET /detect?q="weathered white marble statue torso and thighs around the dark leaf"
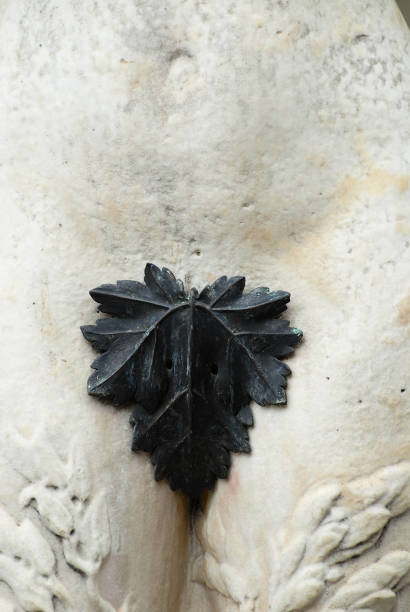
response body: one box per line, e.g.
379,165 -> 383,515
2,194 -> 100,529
0,0 -> 410,612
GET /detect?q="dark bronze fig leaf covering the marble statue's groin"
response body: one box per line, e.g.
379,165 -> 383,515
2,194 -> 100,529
81,264 -> 302,501
